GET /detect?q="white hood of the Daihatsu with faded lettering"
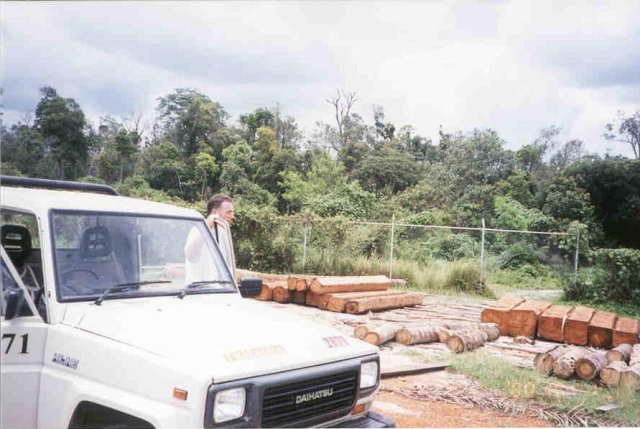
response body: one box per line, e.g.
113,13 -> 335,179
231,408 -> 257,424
62,294 -> 377,383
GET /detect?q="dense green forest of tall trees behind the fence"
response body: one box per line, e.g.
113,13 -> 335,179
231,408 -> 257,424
1,87 -> 640,305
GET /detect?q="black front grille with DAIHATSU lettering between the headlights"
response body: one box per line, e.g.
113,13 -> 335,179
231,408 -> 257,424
262,371 -> 358,427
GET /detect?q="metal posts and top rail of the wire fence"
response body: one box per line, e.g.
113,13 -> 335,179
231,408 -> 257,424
280,215 -> 580,283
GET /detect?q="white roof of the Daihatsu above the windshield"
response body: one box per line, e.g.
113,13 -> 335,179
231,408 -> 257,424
0,186 -> 202,219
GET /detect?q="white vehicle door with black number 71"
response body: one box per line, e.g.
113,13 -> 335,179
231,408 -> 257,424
0,248 -> 48,429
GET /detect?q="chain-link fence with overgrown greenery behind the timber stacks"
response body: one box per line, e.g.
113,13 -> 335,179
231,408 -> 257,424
236,218 -> 580,290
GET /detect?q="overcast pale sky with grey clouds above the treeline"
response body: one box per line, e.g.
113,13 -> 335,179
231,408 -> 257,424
0,0 -> 640,155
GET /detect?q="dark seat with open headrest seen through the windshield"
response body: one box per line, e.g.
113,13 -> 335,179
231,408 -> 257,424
73,225 -> 126,289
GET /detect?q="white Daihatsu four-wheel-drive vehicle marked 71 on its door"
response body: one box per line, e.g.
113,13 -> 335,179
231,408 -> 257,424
0,176 -> 393,429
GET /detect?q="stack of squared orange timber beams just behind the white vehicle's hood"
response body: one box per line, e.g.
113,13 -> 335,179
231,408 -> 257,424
236,269 -> 422,314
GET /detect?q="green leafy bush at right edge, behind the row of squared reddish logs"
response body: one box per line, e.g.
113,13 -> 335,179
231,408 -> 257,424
565,248 -> 640,305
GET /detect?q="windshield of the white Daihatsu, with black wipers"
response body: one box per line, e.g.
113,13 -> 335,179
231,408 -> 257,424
51,211 -> 236,301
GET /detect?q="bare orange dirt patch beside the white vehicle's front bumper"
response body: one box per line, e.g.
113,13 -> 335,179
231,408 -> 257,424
373,374 -> 552,428
